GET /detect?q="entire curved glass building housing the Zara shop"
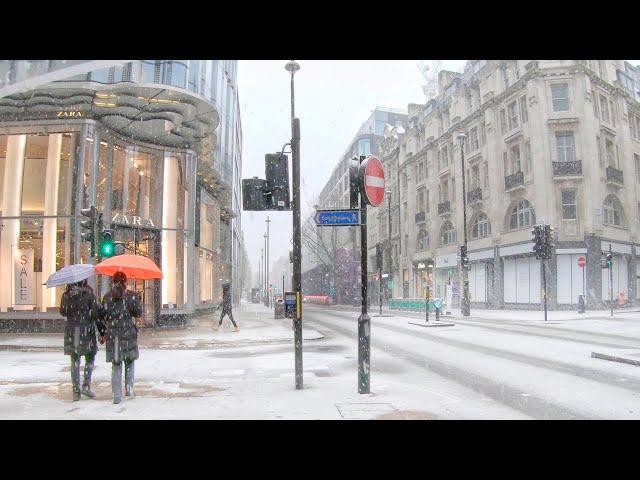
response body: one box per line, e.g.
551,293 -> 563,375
0,60 -> 241,329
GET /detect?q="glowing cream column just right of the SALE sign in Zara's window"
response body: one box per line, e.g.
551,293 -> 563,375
41,133 -> 62,312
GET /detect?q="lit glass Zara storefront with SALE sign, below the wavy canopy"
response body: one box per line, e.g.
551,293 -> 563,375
0,114 -> 197,330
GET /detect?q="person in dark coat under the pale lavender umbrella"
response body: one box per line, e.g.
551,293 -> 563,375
60,280 -> 104,402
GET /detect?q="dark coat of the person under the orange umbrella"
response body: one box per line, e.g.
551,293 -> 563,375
101,290 -> 142,363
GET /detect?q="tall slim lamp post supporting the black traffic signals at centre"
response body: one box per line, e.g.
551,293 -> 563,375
285,60 -> 302,390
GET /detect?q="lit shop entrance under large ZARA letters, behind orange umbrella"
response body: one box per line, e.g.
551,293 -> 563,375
113,225 -> 162,326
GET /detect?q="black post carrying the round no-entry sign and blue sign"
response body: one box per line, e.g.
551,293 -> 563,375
358,161 -> 371,393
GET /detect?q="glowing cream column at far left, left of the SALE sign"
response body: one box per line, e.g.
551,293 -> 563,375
0,135 -> 27,312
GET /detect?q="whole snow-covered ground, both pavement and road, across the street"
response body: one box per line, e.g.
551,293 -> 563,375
0,304 -> 640,419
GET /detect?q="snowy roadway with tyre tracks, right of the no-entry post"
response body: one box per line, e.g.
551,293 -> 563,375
305,305 -> 640,419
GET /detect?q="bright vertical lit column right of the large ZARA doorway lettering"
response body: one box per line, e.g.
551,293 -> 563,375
162,153 -> 179,307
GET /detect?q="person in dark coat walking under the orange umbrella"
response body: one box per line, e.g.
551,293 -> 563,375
101,272 -> 142,403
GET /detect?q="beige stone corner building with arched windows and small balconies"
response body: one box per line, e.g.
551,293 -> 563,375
368,60 -> 640,309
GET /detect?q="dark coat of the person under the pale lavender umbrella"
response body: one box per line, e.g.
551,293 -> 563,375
60,285 -> 102,355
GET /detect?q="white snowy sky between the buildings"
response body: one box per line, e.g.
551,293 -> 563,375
238,60 -> 472,284
